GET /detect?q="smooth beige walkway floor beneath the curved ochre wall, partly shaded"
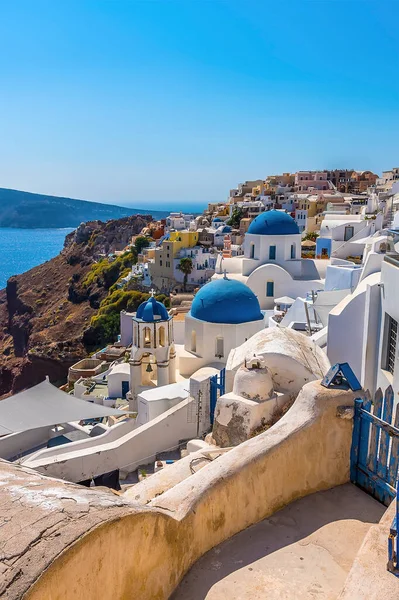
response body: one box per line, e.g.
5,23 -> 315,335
172,484 -> 386,600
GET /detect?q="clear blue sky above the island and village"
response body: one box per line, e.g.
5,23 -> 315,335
0,0 -> 399,208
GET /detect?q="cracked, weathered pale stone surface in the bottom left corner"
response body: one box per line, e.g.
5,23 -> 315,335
0,460 -> 132,599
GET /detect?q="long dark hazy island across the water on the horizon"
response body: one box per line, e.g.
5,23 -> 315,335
0,188 -> 169,229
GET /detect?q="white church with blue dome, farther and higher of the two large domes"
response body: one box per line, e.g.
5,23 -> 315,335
213,210 -> 324,310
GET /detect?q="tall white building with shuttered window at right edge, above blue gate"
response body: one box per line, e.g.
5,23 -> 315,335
327,238 -> 399,401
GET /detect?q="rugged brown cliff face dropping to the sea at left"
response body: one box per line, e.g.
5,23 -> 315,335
0,215 -> 151,398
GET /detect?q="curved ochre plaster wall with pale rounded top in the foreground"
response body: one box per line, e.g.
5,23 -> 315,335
17,382 -> 360,600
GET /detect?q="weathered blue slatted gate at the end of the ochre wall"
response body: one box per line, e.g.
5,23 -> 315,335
350,386 -> 399,506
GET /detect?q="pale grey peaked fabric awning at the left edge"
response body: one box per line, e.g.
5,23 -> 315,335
0,379 -> 129,436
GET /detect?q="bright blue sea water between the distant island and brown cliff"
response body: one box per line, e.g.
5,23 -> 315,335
0,227 -> 73,289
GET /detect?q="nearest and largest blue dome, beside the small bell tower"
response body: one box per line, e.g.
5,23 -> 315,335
190,279 -> 263,324
